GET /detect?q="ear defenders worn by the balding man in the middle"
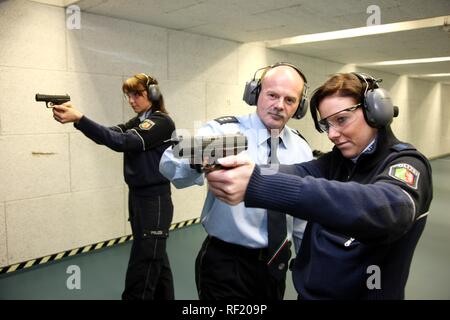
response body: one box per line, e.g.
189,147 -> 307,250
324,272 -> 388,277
242,62 -> 308,119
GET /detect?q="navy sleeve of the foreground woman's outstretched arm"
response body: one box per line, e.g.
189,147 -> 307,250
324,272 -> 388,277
245,158 -> 428,242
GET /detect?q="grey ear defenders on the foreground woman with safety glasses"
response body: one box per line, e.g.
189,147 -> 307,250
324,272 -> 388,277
352,72 -> 398,128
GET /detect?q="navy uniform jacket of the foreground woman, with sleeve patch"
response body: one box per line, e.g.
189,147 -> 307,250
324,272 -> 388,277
245,128 -> 432,299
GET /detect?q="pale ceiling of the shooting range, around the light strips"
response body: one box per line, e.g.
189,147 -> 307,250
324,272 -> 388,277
41,0 -> 450,83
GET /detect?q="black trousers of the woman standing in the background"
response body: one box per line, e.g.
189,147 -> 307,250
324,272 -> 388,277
122,190 -> 175,300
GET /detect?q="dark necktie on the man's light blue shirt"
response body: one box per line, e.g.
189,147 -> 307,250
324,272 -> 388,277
267,138 -> 291,280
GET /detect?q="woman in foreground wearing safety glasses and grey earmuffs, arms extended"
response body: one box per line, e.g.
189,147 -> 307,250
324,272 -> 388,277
207,73 -> 432,299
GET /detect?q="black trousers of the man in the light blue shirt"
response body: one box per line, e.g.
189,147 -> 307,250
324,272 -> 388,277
195,236 -> 286,300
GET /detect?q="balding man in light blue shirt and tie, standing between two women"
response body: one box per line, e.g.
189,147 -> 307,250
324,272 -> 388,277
160,63 -> 312,300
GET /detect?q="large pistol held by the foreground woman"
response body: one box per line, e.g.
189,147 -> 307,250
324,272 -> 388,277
171,133 -> 248,172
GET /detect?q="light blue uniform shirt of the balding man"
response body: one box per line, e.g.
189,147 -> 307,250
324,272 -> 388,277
159,113 -> 313,248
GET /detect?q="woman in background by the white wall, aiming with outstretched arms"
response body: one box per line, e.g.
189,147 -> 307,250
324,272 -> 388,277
53,73 -> 175,299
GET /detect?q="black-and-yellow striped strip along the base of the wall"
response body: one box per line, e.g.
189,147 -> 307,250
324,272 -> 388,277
0,218 -> 200,274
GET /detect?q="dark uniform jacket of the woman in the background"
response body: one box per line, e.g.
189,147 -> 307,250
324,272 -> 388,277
75,111 -> 175,196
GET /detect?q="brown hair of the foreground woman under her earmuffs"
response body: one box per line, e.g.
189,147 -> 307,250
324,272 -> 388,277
310,73 -> 365,131
